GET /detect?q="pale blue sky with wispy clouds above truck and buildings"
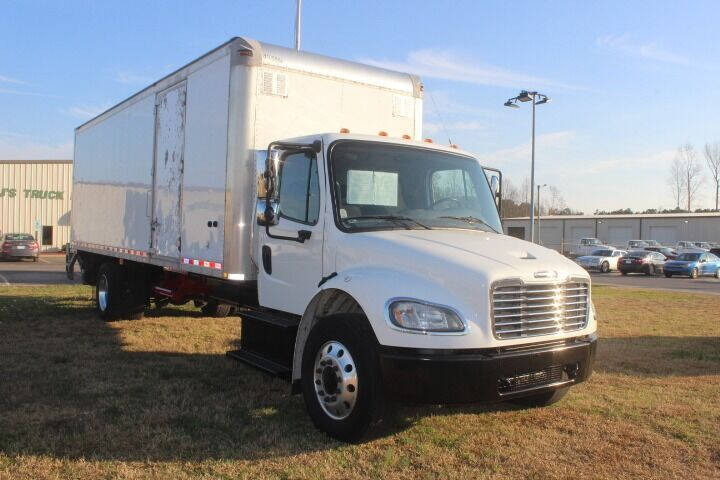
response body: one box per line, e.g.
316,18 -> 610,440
0,0 -> 720,213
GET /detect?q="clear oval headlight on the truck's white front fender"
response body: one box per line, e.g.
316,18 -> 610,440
389,300 -> 465,332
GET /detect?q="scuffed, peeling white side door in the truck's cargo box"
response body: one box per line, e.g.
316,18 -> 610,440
150,82 -> 186,258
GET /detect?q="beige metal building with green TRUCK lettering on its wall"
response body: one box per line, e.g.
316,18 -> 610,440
0,160 -> 72,251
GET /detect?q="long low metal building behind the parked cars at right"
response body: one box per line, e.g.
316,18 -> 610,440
503,213 -> 720,253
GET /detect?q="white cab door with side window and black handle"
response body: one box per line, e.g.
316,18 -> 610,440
255,150 -> 324,315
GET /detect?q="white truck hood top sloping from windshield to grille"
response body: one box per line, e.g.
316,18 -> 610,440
335,229 -> 589,283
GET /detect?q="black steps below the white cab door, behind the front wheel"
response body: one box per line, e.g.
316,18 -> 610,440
227,308 -> 301,380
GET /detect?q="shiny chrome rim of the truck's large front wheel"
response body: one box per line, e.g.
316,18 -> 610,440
313,341 -> 358,420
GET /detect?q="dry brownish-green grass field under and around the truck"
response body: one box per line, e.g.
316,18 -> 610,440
0,286 -> 720,479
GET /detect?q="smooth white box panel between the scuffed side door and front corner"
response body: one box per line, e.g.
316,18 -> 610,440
181,56 -> 230,263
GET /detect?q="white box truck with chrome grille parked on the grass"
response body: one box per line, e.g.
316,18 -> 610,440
68,38 -> 596,441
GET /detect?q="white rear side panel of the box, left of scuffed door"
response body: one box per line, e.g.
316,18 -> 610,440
72,95 -> 155,252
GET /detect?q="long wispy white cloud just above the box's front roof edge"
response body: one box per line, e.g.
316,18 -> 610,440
360,49 -> 580,90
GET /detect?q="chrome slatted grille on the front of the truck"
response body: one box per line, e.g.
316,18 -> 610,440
492,281 -> 590,340
